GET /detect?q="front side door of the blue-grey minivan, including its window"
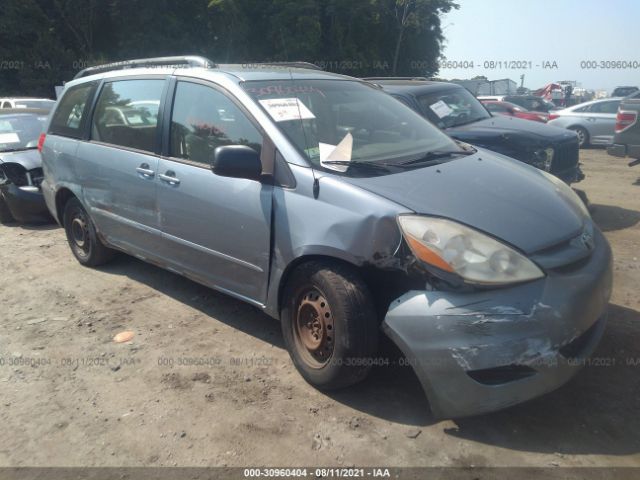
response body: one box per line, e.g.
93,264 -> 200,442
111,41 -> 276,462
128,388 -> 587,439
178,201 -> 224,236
157,80 -> 273,304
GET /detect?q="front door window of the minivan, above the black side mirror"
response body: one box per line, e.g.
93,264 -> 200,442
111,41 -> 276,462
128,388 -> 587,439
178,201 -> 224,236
170,82 -> 262,165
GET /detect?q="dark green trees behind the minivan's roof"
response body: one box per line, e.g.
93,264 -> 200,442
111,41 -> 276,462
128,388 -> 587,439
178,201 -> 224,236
0,0 -> 458,96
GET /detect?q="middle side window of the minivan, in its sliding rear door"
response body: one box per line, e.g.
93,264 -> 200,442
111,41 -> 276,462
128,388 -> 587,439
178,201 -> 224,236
91,79 -> 165,152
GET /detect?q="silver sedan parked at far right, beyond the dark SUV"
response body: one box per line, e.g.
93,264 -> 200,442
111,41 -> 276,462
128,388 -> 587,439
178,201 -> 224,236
548,98 -> 621,147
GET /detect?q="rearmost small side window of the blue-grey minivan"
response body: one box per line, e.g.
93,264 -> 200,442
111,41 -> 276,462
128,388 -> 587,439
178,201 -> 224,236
49,82 -> 97,138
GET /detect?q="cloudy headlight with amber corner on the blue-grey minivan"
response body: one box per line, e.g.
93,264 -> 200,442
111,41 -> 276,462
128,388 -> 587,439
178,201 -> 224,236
398,215 -> 544,285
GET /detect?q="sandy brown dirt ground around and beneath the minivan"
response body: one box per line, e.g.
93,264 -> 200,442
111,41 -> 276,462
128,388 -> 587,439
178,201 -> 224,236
0,149 -> 640,466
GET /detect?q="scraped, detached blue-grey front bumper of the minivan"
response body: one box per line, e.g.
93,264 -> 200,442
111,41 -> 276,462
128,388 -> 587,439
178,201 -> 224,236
383,231 -> 612,418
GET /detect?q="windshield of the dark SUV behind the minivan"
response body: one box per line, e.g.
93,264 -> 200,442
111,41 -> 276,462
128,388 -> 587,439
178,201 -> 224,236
418,88 -> 490,128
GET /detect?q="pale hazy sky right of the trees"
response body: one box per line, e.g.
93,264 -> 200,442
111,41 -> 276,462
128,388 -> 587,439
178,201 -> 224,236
438,0 -> 640,92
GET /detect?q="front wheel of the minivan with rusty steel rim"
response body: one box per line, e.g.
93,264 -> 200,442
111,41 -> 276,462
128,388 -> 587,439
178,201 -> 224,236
281,261 -> 379,390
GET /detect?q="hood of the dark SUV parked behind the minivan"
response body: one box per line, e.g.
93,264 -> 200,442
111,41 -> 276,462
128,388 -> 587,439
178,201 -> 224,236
445,115 -> 575,144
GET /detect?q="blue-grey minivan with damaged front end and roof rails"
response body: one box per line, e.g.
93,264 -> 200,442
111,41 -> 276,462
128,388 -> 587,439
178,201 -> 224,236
42,57 -> 611,417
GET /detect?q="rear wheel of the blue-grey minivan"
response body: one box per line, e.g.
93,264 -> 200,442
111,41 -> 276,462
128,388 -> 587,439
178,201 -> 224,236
63,198 -> 115,267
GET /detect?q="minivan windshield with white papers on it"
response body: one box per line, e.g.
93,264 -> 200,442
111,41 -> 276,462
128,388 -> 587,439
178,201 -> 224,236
243,80 -> 460,171
